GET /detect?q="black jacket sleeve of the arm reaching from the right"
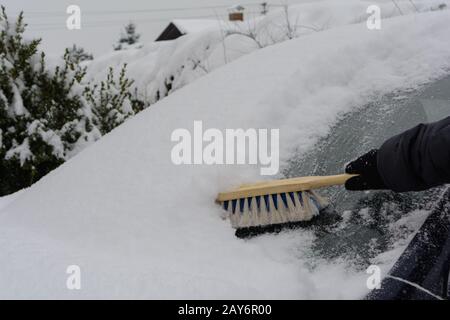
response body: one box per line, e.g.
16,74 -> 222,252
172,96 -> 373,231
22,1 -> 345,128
377,117 -> 450,192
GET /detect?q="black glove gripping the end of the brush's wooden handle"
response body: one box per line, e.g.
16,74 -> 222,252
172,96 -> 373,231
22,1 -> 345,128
345,149 -> 388,190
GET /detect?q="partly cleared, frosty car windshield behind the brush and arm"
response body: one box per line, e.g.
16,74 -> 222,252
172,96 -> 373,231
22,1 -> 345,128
284,77 -> 450,269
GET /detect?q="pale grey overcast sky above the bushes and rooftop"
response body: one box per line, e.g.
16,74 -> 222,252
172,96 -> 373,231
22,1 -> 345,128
2,0 -> 311,56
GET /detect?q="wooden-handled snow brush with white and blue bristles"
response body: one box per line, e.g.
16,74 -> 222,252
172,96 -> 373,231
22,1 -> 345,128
216,174 -> 355,237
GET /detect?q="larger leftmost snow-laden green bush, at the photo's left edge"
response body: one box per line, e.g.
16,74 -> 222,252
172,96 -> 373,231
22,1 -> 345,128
0,8 -> 84,195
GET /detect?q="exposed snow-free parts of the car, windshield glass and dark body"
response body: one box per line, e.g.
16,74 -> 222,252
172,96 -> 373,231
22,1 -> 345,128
285,76 -> 450,300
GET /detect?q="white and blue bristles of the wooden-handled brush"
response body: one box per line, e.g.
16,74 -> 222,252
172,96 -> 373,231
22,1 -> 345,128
223,191 -> 327,229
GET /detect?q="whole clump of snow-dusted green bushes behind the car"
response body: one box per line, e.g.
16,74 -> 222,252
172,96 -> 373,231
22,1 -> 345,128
0,7 -> 144,196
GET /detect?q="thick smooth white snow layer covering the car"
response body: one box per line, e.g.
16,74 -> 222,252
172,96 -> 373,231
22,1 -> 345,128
0,6 -> 450,299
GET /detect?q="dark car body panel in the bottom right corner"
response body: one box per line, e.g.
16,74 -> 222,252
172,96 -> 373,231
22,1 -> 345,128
367,189 -> 450,300
